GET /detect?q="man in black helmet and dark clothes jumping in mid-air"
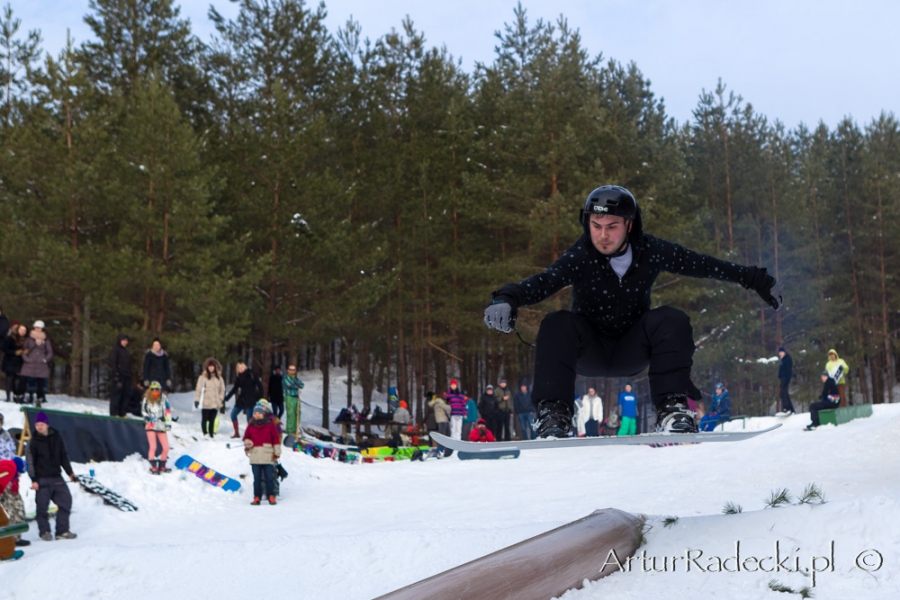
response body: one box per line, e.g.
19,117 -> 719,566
484,185 -> 782,438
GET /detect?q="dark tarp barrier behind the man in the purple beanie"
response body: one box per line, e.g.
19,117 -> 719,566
22,406 -> 150,463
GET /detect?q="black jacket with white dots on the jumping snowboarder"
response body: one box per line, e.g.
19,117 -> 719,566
493,234 -> 755,337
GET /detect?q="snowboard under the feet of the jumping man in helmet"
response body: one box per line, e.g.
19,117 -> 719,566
430,423 -> 781,452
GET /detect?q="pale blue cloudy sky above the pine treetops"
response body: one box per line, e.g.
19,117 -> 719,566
11,0 -> 900,127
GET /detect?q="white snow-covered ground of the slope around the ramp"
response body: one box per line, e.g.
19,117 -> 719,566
0,373 -> 900,600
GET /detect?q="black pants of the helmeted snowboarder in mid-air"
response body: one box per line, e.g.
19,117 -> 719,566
532,306 -> 701,407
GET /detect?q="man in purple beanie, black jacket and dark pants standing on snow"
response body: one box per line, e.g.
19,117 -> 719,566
25,411 -> 78,542
